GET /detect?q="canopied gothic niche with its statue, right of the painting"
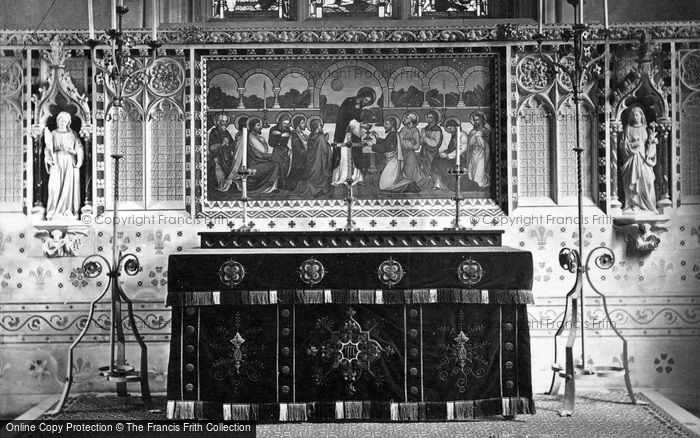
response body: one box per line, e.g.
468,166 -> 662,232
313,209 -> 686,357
611,41 -> 673,216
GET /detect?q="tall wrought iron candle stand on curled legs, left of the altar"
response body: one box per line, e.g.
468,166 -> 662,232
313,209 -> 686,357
47,6 -> 158,415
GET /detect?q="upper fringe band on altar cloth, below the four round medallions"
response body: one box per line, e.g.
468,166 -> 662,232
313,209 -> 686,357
166,289 -> 535,306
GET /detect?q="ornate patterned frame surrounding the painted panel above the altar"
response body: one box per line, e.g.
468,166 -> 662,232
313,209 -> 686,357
192,46 -> 508,222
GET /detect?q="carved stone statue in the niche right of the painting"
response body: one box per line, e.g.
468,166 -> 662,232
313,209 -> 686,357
618,106 -> 659,213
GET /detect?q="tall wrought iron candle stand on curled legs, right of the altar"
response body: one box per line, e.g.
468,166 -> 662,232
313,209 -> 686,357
535,0 -> 637,416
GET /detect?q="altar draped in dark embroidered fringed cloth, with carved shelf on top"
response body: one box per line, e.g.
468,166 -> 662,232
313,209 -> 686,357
167,231 -> 535,422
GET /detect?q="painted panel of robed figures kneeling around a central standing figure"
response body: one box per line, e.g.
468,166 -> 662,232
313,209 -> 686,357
202,53 -> 500,201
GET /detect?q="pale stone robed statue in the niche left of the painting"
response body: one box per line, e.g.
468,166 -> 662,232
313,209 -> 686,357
44,111 -> 83,220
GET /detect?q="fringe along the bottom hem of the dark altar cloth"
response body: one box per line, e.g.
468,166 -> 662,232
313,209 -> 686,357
167,397 -> 535,423
